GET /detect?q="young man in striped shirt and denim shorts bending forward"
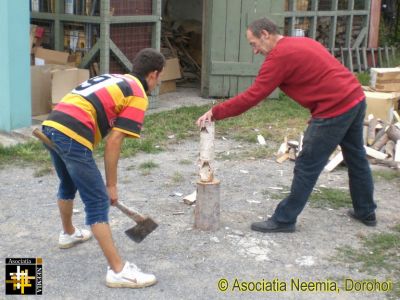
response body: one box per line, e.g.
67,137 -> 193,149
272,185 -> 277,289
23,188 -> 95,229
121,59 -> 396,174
35,48 -> 165,288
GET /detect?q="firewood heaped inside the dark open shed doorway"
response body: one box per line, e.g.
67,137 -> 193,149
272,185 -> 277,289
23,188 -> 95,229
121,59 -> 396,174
161,21 -> 202,81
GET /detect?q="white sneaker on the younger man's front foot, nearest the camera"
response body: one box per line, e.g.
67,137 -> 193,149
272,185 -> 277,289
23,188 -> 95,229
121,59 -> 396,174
106,262 -> 157,289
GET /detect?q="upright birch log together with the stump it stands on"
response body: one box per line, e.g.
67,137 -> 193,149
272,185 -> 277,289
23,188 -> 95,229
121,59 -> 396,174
194,122 -> 220,230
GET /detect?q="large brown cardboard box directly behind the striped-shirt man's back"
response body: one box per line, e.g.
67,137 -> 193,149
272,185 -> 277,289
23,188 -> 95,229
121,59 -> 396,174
31,64 -> 89,116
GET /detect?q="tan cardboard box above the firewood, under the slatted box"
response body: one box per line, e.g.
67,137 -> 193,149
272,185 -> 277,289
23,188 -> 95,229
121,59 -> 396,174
364,91 -> 400,123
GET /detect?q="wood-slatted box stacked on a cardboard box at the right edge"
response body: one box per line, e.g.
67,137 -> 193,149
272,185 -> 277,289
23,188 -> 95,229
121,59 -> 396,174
370,68 -> 400,92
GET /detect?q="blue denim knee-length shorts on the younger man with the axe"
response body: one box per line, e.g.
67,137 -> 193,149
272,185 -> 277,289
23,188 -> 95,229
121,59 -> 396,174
43,126 -> 110,225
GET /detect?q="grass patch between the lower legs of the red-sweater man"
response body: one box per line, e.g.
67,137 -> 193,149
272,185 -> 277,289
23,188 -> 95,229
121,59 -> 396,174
310,187 -> 351,209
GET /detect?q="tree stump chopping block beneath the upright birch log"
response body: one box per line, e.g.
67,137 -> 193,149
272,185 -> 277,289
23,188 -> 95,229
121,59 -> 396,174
194,178 -> 220,231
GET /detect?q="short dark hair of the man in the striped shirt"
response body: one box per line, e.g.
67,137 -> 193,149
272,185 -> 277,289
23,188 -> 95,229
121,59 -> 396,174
131,48 -> 165,78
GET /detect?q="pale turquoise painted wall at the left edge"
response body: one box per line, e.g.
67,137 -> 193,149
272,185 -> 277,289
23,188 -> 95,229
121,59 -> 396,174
0,0 -> 31,131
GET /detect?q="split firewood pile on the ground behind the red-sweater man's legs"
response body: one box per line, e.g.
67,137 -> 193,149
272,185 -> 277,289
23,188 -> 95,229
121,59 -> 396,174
276,111 -> 400,172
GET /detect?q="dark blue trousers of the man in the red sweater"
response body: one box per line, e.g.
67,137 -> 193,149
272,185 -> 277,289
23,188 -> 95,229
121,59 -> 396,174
272,101 -> 376,223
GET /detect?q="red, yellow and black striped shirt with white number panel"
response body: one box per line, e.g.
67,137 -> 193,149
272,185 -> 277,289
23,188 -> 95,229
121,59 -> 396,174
43,74 -> 148,150
